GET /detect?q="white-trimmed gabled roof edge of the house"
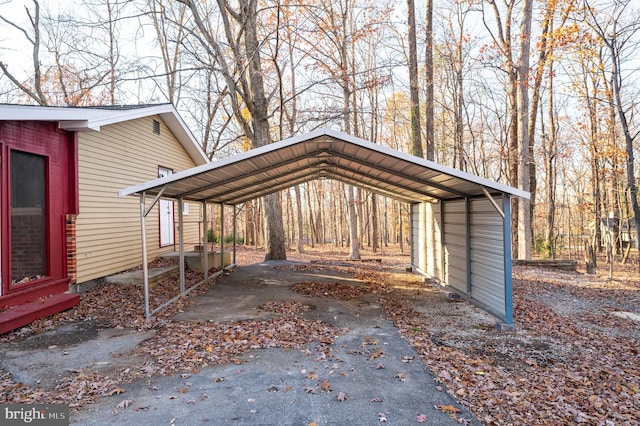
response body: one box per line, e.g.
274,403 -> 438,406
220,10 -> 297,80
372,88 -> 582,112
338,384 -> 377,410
0,104 -> 209,165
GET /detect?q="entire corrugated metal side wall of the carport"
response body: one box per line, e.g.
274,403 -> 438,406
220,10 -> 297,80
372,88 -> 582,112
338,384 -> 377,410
411,198 -> 510,319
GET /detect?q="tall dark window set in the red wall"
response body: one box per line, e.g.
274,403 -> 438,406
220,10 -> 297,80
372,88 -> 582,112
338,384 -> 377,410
10,151 -> 47,284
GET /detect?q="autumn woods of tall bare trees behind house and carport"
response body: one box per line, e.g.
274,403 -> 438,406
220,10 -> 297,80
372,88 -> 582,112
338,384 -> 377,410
0,0 -> 640,261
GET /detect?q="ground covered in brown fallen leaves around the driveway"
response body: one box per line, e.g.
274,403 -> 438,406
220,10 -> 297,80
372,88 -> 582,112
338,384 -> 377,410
0,247 -> 640,425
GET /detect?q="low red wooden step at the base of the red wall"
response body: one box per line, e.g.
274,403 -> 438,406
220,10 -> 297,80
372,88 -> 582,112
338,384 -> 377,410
0,293 -> 80,334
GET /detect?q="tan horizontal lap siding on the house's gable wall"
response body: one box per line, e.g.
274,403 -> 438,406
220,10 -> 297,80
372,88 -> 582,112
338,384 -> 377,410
76,116 -> 200,282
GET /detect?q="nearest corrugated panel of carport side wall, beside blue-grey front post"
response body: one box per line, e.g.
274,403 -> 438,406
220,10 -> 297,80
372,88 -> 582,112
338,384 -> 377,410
469,198 -> 506,318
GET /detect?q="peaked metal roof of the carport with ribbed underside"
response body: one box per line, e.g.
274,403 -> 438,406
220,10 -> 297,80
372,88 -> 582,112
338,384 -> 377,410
119,129 -> 529,205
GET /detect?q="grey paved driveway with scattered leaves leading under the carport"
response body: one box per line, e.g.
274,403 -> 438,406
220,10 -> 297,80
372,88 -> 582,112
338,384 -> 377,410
5,261 -> 477,425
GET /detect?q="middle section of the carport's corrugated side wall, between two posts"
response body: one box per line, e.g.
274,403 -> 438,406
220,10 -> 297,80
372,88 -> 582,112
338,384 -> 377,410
443,200 -> 467,294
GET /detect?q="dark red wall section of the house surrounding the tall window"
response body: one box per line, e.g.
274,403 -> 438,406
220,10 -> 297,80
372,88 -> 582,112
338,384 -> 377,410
0,121 -> 78,306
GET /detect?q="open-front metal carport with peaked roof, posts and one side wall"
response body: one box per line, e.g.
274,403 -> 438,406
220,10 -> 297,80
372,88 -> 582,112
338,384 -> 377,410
119,129 -> 529,327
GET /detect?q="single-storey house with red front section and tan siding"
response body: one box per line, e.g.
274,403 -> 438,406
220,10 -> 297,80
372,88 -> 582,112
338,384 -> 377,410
0,104 -> 208,333
